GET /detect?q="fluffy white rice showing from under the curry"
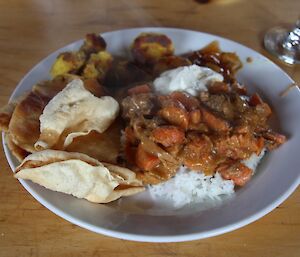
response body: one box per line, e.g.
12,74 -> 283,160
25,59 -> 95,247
149,150 -> 265,208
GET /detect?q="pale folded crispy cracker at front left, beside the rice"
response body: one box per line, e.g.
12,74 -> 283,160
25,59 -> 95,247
15,150 -> 144,203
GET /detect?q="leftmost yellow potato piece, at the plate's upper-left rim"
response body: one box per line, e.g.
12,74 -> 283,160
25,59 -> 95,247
50,52 -> 86,78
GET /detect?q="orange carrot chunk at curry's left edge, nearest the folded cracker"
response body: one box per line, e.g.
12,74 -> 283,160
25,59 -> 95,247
135,144 -> 160,171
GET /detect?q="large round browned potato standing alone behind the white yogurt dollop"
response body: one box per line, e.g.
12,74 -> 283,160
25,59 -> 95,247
131,33 -> 174,65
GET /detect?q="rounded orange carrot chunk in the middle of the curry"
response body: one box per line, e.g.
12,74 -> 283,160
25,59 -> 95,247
152,126 -> 185,147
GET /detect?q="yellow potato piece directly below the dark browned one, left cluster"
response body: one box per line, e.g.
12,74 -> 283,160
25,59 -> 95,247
82,51 -> 113,81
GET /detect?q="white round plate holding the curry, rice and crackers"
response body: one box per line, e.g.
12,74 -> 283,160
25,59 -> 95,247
3,28 -> 300,242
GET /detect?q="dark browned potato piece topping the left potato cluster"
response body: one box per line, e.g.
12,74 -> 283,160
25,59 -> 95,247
80,33 -> 106,56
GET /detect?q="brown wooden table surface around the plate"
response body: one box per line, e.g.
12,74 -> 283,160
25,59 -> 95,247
0,0 -> 300,257
